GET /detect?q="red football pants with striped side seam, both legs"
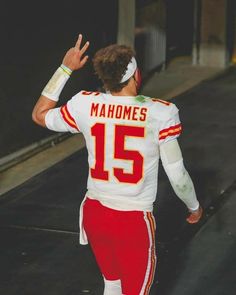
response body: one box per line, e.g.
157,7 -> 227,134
83,198 -> 156,295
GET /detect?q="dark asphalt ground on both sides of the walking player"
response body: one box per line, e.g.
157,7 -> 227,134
0,68 -> 236,295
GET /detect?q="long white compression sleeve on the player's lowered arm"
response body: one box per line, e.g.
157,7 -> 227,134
160,139 -> 199,211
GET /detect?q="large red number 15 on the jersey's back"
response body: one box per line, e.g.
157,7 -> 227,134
90,123 -> 145,183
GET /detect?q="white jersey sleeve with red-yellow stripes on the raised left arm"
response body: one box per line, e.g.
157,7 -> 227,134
45,98 -> 80,133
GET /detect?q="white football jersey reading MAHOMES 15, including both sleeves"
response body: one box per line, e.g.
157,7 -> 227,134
45,91 -> 181,211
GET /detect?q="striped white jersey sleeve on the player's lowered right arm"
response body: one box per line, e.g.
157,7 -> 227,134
158,103 -> 182,144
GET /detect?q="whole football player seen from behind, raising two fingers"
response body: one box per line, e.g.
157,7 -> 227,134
32,35 -> 202,295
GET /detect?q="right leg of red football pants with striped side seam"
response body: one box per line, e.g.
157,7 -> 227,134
116,212 -> 156,295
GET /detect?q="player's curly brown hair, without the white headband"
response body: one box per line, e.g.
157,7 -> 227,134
93,44 -> 135,92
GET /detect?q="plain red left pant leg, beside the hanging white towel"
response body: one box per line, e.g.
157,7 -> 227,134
83,200 -> 119,280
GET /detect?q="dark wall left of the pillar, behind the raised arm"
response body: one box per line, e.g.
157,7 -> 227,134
0,0 -> 118,158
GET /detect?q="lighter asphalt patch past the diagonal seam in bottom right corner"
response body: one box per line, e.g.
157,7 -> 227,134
165,182 -> 236,295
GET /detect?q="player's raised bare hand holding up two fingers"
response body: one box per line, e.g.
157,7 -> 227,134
62,34 -> 89,71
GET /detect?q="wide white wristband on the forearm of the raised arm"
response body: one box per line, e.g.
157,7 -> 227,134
42,65 -> 72,101
